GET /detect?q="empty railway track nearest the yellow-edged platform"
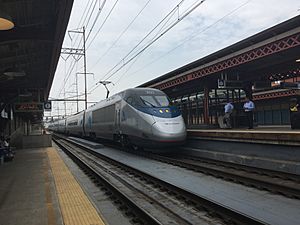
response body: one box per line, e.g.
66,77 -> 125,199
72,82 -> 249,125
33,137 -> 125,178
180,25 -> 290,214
55,135 -> 264,224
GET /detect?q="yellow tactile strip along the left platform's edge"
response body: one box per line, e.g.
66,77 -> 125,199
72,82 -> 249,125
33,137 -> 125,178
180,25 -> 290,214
47,148 -> 105,225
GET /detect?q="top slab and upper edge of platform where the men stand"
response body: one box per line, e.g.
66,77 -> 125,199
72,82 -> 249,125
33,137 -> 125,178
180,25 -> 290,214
187,126 -> 300,146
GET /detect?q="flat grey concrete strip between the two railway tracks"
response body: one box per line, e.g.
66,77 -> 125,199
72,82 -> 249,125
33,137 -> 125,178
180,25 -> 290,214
75,142 -> 300,225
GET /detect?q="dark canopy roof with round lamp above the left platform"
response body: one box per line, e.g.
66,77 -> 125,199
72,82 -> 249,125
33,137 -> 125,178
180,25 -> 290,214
0,0 -> 73,112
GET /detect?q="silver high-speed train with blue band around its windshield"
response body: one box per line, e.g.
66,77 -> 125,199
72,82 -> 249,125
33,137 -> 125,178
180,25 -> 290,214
48,88 -> 186,149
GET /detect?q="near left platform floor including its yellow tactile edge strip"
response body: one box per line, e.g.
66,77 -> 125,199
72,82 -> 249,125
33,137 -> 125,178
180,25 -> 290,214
0,147 -> 104,225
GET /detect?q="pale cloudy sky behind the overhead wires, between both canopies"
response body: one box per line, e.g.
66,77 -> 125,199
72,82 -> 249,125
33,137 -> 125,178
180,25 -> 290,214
45,0 -> 300,116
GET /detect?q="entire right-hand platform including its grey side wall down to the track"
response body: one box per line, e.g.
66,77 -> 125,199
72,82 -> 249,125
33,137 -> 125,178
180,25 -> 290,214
184,126 -> 300,175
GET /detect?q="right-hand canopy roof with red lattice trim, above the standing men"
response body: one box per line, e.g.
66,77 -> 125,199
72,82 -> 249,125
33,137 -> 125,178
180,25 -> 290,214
140,16 -> 300,97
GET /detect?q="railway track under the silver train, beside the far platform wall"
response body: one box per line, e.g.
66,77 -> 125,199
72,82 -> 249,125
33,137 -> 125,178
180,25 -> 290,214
145,149 -> 300,199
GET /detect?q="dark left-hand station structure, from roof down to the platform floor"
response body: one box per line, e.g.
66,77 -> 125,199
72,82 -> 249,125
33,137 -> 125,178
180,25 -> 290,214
0,0 -> 73,147
